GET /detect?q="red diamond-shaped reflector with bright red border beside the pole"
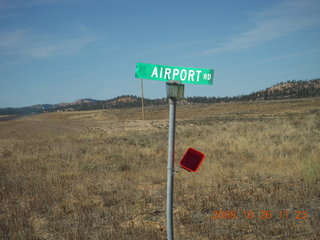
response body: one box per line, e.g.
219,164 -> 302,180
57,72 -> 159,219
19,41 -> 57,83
180,148 -> 205,172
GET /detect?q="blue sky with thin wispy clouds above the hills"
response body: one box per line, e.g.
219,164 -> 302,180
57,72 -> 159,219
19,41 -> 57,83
0,0 -> 320,108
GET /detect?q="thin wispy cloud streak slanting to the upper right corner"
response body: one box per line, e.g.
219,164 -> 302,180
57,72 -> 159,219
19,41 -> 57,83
199,0 -> 320,56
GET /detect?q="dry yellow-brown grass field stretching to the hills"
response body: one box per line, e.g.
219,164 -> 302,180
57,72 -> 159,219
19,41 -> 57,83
0,98 -> 320,240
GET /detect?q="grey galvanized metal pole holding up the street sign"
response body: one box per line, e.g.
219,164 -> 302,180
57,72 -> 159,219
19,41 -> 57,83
167,97 -> 177,240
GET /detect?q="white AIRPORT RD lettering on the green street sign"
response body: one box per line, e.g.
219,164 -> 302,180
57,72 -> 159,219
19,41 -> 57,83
151,67 -> 202,82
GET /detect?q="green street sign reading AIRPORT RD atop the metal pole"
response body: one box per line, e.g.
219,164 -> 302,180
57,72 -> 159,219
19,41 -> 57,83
136,63 -> 214,85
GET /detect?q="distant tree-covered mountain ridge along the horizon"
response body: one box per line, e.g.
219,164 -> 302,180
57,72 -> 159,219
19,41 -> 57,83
0,78 -> 320,115
